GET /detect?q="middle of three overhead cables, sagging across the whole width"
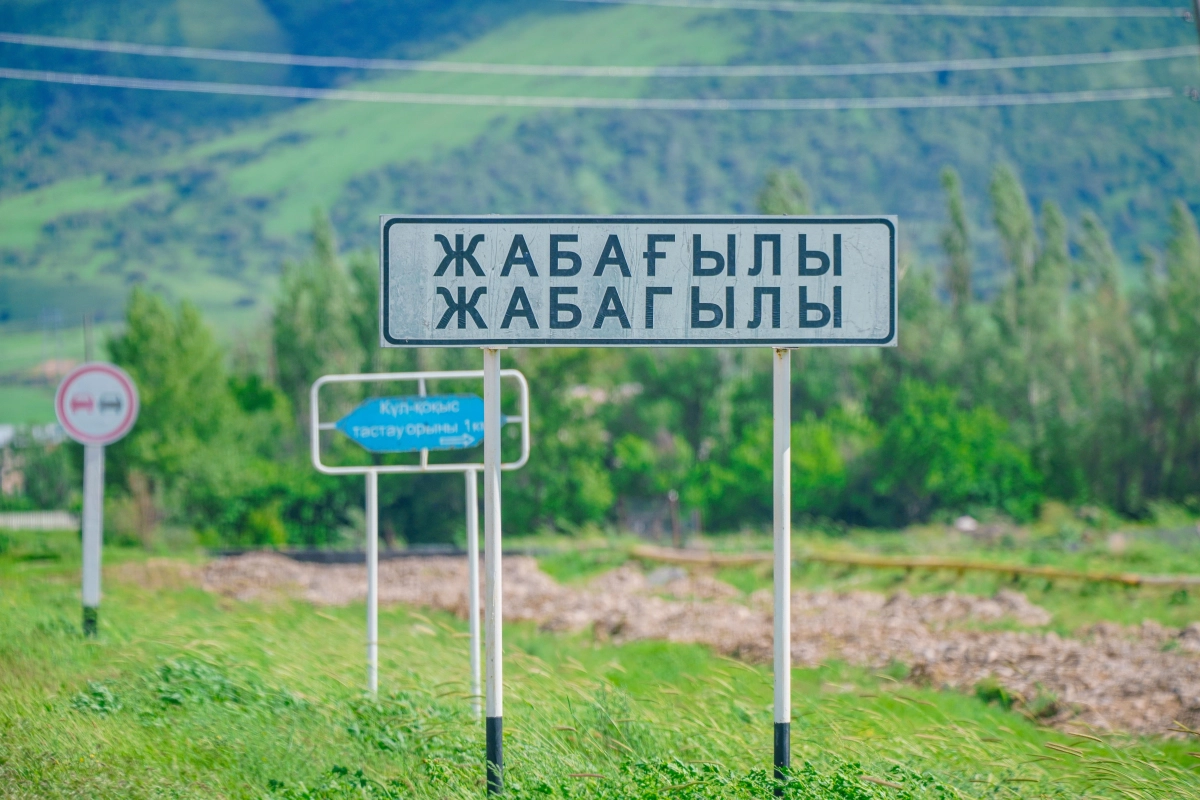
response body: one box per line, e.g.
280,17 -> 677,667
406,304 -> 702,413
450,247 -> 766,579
0,32 -> 1200,78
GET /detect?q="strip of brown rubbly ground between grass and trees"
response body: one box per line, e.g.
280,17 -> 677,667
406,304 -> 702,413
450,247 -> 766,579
200,553 -> 1200,734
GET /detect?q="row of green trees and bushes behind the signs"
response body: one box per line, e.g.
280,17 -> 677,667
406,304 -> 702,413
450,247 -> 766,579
37,169 -> 1200,546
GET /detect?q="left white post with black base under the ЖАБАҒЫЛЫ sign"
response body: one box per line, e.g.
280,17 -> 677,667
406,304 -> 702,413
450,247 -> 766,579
484,348 -> 504,794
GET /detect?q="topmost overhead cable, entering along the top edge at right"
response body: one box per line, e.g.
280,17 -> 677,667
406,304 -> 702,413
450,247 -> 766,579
560,0 -> 1192,19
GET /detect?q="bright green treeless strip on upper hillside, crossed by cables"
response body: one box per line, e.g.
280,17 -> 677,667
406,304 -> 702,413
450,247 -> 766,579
187,6 -> 742,236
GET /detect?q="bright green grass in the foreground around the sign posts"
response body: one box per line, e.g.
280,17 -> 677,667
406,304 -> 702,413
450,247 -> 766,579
0,527 -> 1200,800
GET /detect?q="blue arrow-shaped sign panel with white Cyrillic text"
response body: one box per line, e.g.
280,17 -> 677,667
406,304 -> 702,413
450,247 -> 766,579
337,395 -> 484,452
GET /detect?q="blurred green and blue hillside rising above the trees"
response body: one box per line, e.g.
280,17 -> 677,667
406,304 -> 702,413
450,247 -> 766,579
0,0 -> 1200,324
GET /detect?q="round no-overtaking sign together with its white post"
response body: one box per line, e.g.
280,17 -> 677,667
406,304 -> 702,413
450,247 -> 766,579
54,362 -> 138,636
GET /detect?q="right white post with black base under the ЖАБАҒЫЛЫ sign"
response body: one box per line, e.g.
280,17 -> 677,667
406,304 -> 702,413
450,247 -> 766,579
772,350 -> 792,794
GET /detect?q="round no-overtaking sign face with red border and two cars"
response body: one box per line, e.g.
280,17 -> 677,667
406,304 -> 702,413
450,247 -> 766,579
54,362 -> 138,445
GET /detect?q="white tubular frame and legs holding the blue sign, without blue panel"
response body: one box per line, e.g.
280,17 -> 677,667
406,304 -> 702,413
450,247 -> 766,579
308,369 -> 529,717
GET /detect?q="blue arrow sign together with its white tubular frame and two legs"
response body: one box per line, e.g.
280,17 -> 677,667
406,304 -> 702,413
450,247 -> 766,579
308,369 -> 529,717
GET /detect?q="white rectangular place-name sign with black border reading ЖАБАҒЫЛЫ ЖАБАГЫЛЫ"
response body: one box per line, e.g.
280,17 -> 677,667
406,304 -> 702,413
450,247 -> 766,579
380,216 -> 896,348
